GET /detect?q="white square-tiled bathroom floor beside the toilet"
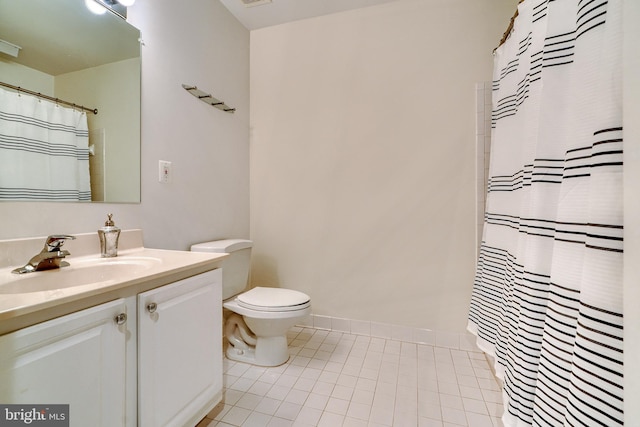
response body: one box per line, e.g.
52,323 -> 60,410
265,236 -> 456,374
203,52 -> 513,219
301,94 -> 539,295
197,327 -> 503,427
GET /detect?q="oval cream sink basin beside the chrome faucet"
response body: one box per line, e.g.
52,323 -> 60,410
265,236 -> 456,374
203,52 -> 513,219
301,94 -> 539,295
0,257 -> 162,295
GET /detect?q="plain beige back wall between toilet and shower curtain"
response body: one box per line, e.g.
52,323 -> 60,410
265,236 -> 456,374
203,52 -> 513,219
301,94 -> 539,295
251,0 -> 517,332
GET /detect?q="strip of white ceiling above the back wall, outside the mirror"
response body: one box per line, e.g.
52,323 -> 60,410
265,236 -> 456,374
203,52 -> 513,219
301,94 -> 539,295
220,0 -> 397,30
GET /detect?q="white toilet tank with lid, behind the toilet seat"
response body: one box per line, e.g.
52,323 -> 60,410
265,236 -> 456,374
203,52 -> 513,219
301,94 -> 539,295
191,239 -> 253,300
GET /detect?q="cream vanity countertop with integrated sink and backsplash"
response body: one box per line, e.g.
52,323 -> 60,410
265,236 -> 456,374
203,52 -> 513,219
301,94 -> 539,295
0,230 -> 228,334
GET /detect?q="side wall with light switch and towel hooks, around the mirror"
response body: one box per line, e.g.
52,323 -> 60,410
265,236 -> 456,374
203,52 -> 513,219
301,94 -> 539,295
0,0 -> 249,251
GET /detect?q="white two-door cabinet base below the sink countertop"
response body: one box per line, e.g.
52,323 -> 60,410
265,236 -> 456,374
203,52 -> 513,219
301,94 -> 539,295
0,269 -> 222,427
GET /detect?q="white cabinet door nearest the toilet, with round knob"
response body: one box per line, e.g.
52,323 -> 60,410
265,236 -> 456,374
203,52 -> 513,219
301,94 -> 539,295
138,269 -> 222,427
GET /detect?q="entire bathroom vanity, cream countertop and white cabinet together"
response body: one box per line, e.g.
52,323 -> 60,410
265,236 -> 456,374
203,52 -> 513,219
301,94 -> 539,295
0,230 -> 226,427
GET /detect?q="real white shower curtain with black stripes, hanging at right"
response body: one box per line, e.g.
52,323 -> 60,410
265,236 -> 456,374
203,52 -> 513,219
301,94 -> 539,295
468,0 -> 623,427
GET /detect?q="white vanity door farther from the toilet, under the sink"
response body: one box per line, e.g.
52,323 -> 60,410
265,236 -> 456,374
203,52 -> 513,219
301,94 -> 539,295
0,299 -> 127,427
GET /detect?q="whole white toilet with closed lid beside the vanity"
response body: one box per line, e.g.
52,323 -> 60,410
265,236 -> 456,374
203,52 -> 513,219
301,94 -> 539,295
191,239 -> 311,366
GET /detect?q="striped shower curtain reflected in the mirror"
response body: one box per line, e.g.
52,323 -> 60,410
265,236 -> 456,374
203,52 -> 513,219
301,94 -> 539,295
0,88 -> 91,201
